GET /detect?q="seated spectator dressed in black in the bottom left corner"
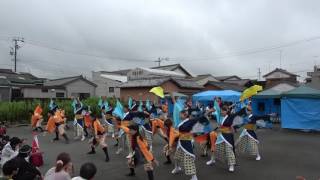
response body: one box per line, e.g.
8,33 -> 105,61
13,145 -> 42,180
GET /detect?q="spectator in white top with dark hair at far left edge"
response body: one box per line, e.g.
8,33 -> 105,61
0,137 -> 22,166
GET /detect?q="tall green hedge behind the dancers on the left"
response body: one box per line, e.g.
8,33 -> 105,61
0,97 -> 116,124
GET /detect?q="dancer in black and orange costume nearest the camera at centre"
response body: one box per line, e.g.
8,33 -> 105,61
122,124 -> 158,180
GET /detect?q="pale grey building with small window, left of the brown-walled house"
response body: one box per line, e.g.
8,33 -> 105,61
92,71 -> 129,98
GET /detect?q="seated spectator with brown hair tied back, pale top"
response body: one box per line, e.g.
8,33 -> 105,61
44,153 -> 73,180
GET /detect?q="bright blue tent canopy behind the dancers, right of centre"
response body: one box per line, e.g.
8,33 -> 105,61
192,90 -> 241,102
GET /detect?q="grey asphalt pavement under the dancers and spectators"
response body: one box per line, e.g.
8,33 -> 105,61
8,127 -> 320,180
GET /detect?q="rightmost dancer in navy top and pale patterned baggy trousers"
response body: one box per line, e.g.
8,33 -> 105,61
236,106 -> 270,161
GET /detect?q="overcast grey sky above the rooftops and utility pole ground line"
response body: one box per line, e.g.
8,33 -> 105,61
0,0 -> 320,78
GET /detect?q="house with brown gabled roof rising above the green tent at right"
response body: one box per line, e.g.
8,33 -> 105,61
263,68 -> 298,88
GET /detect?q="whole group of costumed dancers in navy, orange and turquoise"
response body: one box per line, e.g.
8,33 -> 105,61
31,94 -> 270,180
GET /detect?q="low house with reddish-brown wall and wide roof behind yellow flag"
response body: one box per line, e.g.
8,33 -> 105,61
120,77 -> 203,101
